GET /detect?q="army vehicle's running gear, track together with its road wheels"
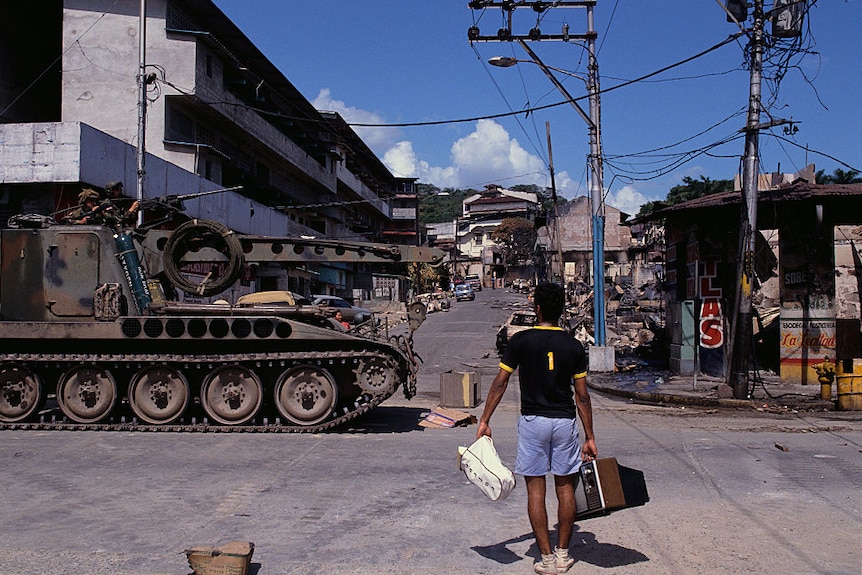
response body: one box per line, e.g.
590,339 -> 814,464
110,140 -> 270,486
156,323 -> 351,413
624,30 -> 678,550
0,350 -> 415,433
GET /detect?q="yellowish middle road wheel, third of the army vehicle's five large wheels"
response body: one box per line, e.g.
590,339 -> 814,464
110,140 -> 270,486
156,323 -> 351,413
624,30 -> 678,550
129,365 -> 191,425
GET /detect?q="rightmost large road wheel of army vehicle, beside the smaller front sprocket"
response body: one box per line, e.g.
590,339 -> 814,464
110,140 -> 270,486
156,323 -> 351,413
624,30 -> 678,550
275,365 -> 338,425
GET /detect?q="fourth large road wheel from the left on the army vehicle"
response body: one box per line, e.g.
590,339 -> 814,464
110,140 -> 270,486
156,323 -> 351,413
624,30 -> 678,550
201,365 -> 263,425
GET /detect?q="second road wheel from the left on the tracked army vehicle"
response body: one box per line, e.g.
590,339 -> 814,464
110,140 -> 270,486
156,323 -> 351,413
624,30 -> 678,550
57,365 -> 117,423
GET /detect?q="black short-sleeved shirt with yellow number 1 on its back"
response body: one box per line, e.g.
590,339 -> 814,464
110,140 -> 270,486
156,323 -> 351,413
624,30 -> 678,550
500,326 -> 587,418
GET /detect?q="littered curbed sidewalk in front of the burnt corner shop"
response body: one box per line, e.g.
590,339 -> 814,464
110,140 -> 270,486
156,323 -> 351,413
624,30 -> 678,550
587,369 -> 862,419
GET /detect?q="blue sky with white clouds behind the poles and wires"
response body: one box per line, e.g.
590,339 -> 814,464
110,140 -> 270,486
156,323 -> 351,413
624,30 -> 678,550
215,0 -> 862,213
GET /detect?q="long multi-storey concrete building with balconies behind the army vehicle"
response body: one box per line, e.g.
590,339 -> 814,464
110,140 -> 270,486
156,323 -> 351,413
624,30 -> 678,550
0,0 -> 415,304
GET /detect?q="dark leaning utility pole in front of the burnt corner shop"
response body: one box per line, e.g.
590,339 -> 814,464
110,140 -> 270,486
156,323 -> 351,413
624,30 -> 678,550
727,0 -> 765,399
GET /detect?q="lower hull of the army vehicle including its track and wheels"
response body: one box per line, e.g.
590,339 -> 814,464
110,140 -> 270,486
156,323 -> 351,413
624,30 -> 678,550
0,316 -> 415,432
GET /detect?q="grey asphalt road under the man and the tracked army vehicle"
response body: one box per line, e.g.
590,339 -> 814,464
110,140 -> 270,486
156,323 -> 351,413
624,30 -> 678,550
0,290 -> 862,575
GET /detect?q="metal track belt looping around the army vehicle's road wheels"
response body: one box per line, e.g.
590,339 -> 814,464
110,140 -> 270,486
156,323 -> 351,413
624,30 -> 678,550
0,350 -> 415,433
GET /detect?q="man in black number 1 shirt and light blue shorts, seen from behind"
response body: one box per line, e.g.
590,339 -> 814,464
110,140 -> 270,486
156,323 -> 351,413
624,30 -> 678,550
476,283 -> 598,575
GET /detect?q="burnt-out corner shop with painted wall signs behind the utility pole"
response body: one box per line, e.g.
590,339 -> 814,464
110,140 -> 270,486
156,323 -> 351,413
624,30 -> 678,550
633,171 -> 862,384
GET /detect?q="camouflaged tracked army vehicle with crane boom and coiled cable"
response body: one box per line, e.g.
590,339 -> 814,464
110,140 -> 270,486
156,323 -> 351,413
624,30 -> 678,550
0,208 -> 442,431
